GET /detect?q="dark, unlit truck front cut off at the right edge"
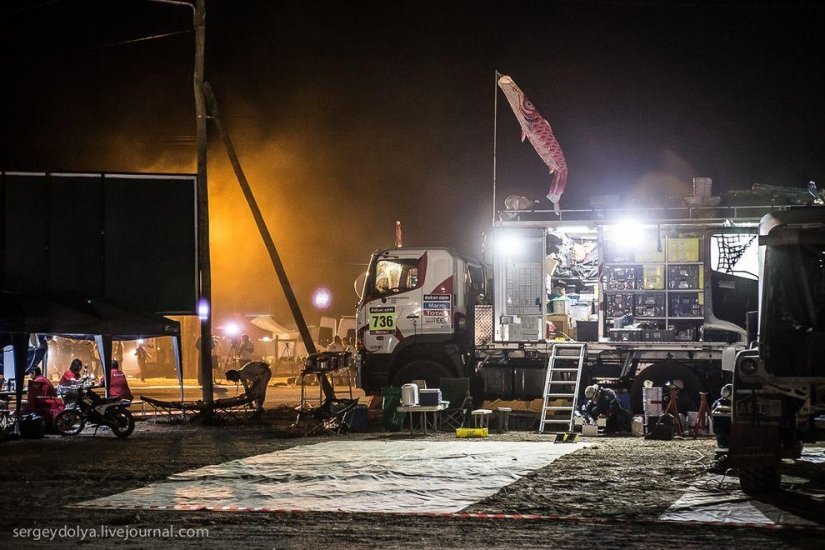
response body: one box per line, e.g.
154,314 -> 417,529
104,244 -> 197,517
728,207 -> 825,494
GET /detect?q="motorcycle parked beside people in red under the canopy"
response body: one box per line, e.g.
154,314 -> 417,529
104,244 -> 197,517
54,381 -> 135,439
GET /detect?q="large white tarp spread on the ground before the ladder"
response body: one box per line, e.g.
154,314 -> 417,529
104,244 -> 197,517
77,440 -> 585,513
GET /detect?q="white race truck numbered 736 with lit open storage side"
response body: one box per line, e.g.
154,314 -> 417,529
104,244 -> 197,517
356,198 -> 816,413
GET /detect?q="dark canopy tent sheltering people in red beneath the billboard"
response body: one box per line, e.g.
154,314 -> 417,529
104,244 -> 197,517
0,291 -> 183,434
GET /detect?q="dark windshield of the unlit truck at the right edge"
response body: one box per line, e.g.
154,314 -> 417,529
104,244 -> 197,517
760,239 -> 825,376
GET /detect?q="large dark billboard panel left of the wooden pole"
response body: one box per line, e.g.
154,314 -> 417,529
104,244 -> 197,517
0,172 -> 198,315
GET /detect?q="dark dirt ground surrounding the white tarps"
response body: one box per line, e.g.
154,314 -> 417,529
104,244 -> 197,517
0,406 -> 825,549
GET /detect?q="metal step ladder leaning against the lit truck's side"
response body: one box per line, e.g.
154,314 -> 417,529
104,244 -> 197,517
539,342 -> 587,433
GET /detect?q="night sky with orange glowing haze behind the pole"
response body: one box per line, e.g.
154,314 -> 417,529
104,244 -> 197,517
0,0 -> 825,324
